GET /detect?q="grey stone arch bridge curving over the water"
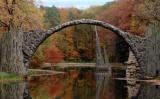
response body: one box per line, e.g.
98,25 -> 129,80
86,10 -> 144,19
23,19 -> 158,76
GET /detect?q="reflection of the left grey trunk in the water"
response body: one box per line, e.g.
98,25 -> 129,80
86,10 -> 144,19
0,82 -> 32,99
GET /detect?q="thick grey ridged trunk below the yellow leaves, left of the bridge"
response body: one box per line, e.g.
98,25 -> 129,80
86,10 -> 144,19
0,27 -> 26,75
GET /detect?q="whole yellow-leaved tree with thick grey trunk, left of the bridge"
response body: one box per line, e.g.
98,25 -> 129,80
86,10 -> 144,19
0,0 -> 43,75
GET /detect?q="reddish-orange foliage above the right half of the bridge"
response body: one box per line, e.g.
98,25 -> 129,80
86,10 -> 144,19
97,0 -> 144,36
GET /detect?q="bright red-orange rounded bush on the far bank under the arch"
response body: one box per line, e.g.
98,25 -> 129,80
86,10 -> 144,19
45,45 -> 64,63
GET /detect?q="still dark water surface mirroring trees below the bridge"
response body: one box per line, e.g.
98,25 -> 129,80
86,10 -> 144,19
0,67 -> 160,99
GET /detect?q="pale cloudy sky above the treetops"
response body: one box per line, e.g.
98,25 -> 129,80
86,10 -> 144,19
37,0 -> 114,9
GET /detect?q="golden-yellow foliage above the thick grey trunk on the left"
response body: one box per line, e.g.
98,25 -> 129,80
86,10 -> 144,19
0,0 -> 43,30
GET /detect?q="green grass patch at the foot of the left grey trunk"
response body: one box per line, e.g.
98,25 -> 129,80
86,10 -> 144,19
0,72 -> 23,81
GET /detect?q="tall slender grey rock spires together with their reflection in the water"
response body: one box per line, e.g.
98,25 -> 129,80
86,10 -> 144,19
95,26 -> 111,99
